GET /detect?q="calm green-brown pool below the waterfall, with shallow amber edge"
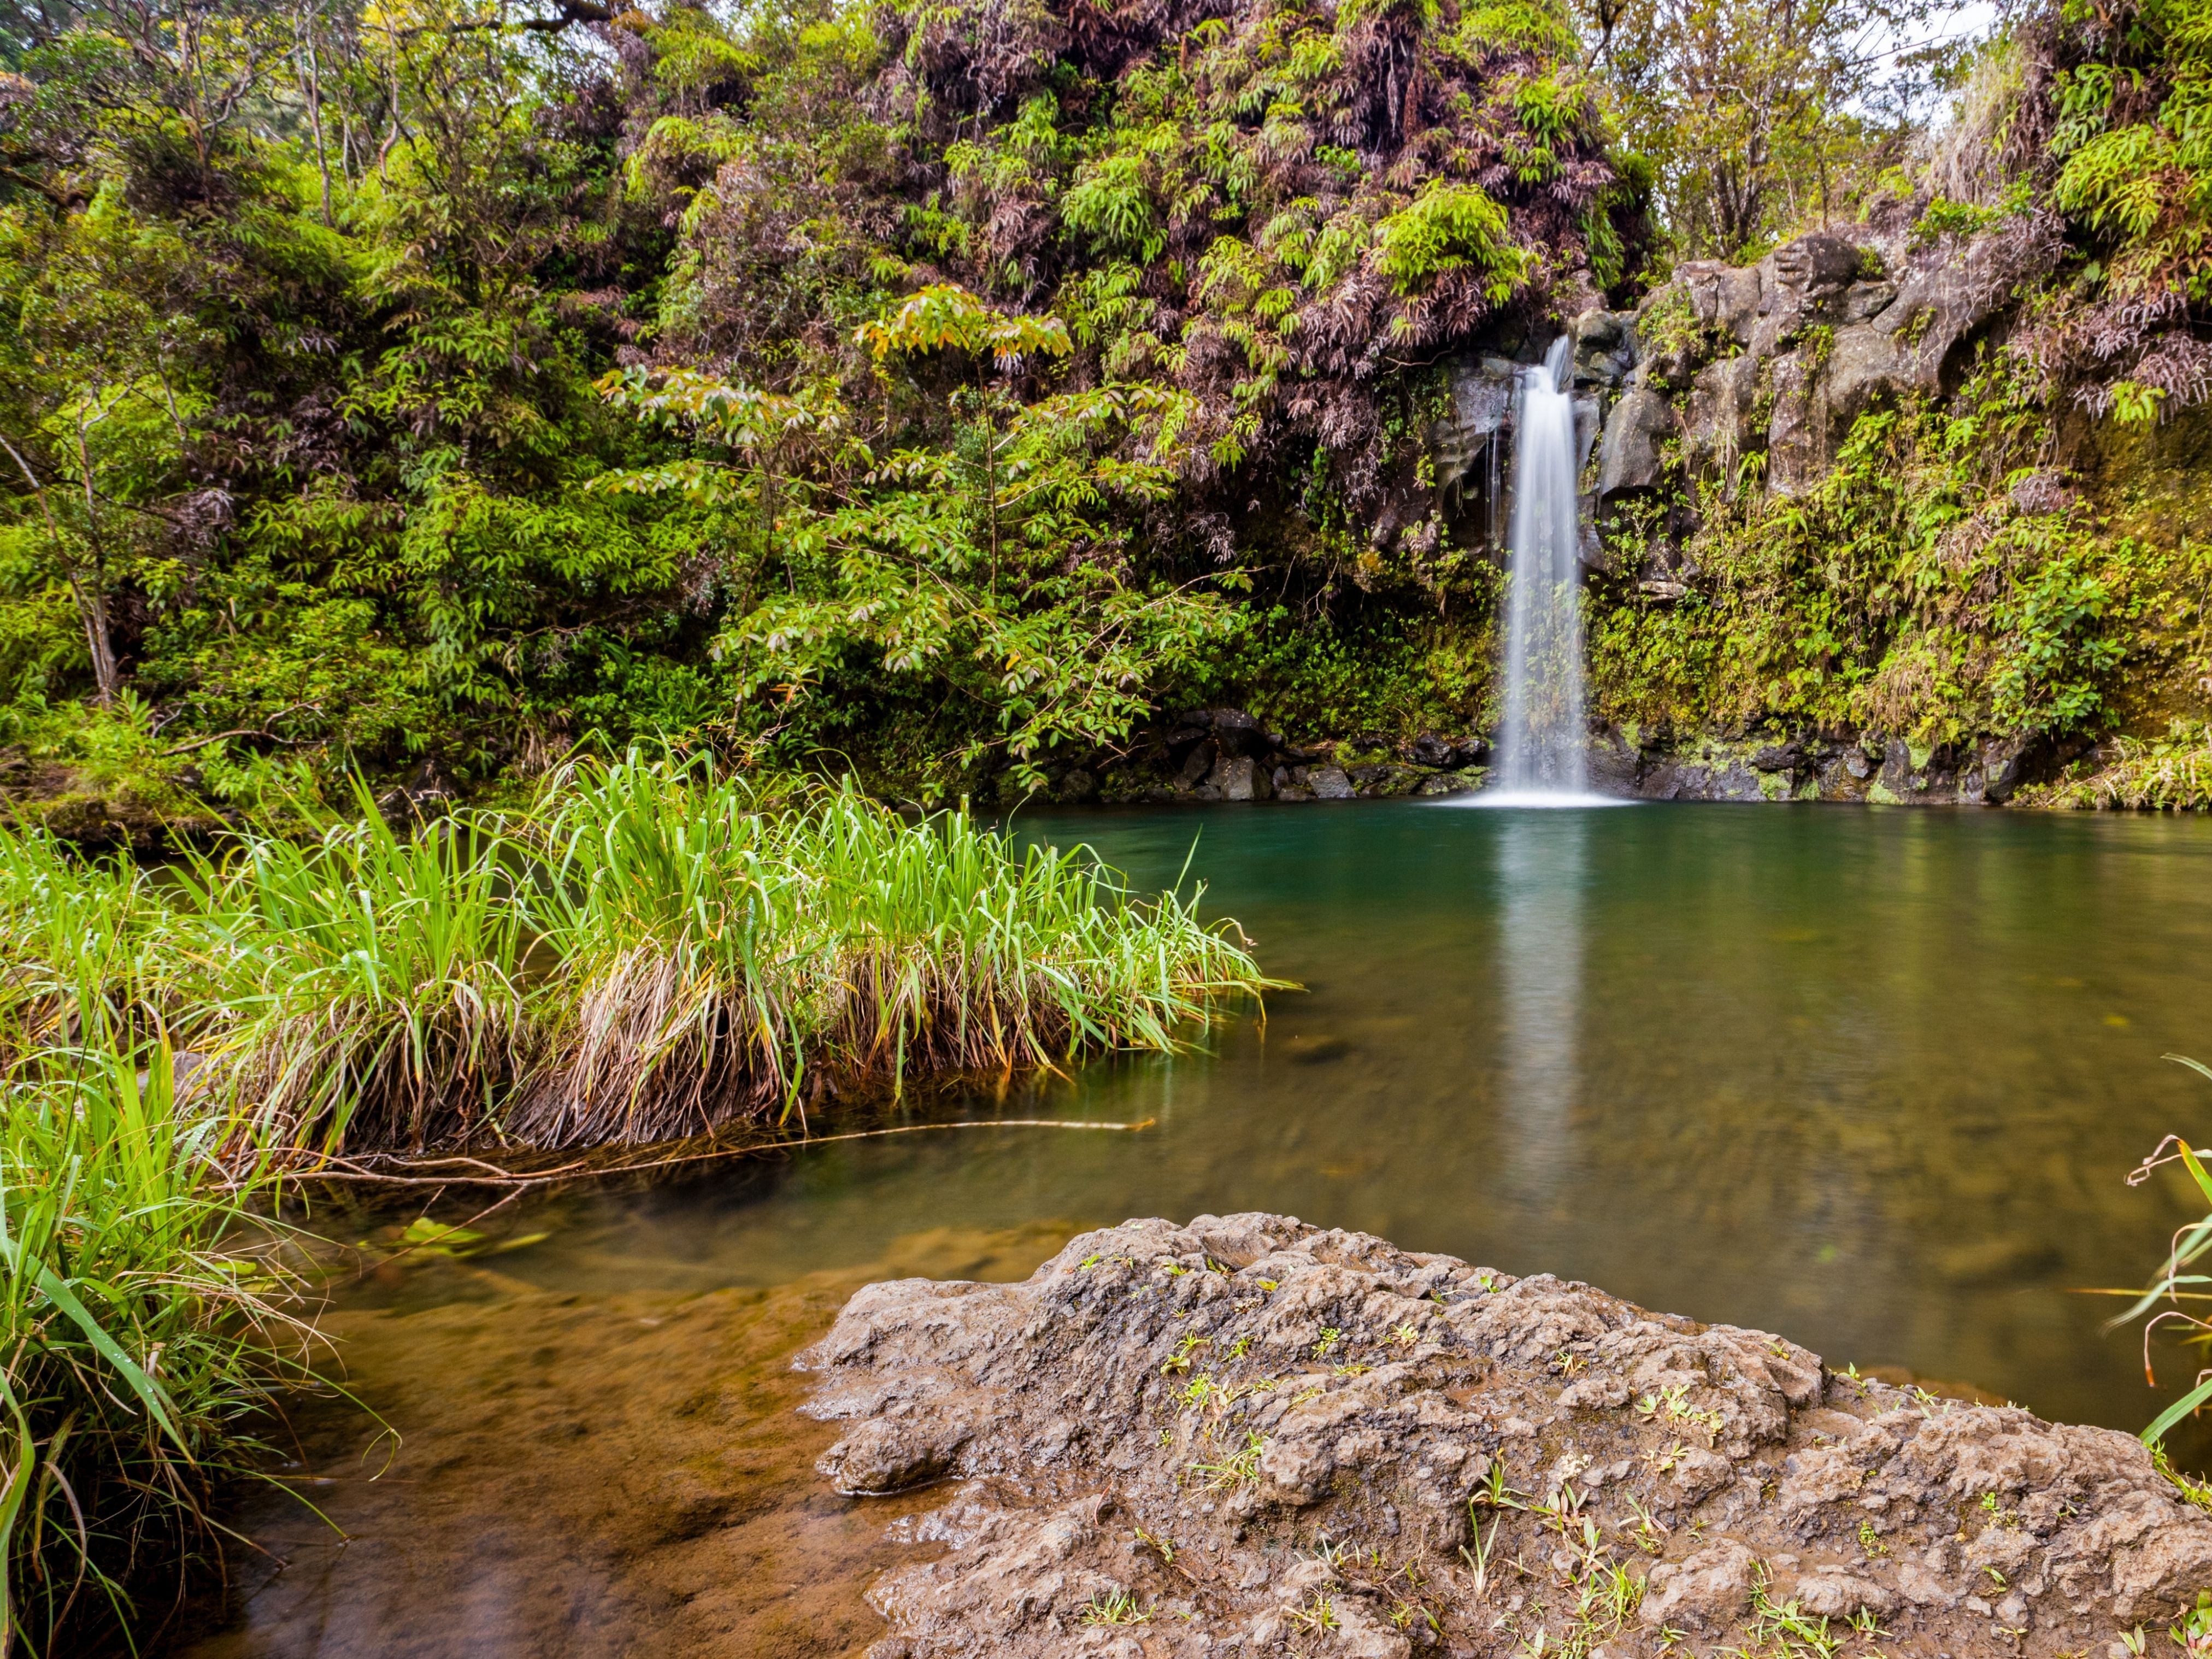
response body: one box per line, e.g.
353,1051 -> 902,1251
177,803 -> 2212,1659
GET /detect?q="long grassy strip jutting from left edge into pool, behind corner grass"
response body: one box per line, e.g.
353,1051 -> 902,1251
0,754 -> 1270,1168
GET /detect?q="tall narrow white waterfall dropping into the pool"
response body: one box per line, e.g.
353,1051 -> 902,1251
1493,334 -> 1591,798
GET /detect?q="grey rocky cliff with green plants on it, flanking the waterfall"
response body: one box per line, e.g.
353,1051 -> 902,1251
1407,201 -> 2168,803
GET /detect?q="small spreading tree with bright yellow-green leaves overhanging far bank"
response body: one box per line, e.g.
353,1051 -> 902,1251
599,285 -> 1239,790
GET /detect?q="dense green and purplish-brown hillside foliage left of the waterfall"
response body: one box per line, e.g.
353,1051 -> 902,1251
0,0 -> 1642,801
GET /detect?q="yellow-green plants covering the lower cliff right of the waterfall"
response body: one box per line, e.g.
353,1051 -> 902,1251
1591,352 -> 2161,745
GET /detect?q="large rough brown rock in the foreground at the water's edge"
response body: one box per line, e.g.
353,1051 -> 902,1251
798,1214 -> 2212,1659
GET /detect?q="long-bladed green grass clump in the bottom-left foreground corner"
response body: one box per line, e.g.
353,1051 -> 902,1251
0,1011 -> 285,1655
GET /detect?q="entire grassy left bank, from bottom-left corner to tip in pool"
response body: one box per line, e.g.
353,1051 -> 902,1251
0,774 -> 1272,1652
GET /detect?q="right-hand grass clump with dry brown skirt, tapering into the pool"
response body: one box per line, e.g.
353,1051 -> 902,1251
511,756 -> 1268,1146
